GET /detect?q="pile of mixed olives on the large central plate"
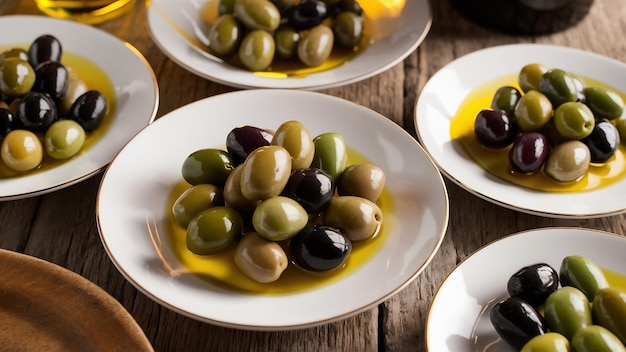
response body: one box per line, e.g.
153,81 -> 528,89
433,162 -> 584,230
171,120 -> 385,283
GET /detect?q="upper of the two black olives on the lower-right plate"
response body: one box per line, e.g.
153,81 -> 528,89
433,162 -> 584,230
507,263 -> 559,308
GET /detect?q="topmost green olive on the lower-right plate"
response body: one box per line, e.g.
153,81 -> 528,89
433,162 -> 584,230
559,255 -> 609,302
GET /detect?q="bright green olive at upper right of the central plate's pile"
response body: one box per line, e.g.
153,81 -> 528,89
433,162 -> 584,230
311,132 -> 348,181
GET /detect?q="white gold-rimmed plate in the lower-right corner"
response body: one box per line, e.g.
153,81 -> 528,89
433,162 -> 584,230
426,228 -> 626,352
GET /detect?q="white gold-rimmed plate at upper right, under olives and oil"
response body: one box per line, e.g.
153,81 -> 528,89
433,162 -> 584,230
415,44 -> 626,218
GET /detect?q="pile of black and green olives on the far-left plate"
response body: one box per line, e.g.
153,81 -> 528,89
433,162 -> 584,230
0,34 -> 107,173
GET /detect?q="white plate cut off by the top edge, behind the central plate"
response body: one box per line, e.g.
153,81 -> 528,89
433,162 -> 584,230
148,0 -> 432,90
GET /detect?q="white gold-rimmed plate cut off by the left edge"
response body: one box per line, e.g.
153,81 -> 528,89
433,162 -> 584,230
0,16 -> 159,200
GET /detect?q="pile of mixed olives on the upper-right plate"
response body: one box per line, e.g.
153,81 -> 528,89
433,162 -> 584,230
474,63 -> 626,182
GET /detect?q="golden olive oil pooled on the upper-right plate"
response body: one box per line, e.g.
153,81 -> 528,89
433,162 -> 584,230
450,74 -> 626,192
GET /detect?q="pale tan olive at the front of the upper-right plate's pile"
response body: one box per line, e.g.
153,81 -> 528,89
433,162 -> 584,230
543,141 -> 591,182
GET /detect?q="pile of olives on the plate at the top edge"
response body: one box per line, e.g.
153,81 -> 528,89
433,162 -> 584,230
202,0 -> 363,71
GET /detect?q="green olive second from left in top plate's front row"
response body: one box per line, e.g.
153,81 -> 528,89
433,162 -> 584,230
238,29 -> 276,71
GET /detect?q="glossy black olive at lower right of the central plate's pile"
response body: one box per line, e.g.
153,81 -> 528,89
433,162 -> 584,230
289,225 -> 352,271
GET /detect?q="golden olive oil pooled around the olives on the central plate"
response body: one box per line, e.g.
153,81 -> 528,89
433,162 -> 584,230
166,150 -> 394,295
